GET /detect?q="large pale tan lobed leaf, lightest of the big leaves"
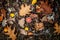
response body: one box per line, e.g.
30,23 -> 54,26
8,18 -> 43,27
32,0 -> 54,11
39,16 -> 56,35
19,4 -> 31,16
